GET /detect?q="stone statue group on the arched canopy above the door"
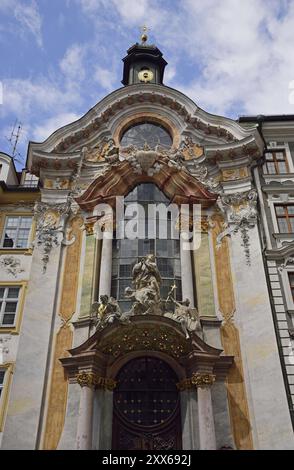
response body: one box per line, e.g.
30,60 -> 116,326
93,254 -> 201,339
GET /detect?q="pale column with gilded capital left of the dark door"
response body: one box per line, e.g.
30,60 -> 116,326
76,372 -> 95,450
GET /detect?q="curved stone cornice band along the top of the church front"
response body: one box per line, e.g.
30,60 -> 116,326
28,85 -> 258,167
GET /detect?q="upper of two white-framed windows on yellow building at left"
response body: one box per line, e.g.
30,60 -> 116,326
2,216 -> 33,248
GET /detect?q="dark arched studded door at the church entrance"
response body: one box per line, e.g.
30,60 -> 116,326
112,357 -> 182,450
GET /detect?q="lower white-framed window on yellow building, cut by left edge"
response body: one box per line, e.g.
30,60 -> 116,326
0,286 -> 20,327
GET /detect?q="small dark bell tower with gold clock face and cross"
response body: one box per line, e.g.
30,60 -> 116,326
122,26 -> 167,86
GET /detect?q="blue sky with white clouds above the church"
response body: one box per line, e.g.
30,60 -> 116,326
0,0 -> 294,169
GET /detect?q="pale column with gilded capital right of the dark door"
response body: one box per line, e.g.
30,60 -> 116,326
191,373 -> 216,450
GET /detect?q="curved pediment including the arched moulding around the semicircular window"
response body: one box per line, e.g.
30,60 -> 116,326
28,84 -> 262,169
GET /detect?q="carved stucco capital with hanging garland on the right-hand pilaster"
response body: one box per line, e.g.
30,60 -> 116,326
216,189 -> 257,266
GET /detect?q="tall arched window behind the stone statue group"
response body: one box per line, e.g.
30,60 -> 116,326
111,183 -> 182,311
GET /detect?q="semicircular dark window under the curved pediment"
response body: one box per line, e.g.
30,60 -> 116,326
120,121 -> 173,149
